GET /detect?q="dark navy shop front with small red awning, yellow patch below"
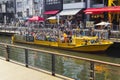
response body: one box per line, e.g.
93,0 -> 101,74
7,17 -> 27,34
44,0 -> 63,24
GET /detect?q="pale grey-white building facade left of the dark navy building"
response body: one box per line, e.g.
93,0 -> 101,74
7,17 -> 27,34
16,0 -> 43,17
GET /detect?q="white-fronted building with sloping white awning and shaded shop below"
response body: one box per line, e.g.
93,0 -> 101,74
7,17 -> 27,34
54,0 -> 86,24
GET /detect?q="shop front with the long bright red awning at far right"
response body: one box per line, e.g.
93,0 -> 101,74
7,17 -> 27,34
84,6 -> 120,29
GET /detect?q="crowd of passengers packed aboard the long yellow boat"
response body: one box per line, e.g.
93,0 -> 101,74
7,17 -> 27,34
17,25 -> 110,43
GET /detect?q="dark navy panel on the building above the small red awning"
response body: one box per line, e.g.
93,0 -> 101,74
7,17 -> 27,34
44,0 -> 63,11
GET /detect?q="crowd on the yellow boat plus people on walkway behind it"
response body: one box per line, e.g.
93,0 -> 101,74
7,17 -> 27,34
13,16 -> 111,42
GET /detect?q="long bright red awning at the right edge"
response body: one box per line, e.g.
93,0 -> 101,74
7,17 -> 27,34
84,6 -> 120,14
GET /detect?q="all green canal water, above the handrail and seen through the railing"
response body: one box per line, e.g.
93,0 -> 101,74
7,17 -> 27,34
0,35 -> 120,80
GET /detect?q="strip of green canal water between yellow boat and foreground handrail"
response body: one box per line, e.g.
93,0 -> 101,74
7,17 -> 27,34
0,35 -> 120,63
